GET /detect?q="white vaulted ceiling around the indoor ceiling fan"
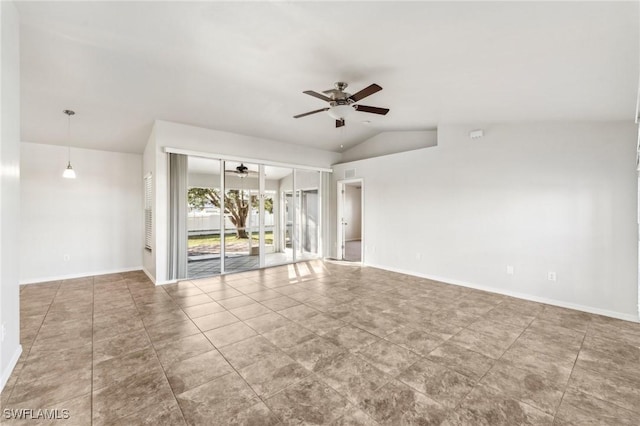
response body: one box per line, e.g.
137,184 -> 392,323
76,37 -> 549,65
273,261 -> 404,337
18,1 -> 639,153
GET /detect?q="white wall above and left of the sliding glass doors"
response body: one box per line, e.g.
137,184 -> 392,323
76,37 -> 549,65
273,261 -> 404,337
143,121 -> 340,284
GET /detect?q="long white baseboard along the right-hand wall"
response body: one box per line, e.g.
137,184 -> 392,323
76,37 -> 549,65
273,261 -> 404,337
364,263 -> 640,322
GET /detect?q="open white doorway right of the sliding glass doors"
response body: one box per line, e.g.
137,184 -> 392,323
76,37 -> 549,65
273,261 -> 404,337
338,179 -> 364,262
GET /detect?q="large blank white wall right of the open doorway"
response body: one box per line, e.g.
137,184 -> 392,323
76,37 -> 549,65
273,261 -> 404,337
331,123 -> 638,319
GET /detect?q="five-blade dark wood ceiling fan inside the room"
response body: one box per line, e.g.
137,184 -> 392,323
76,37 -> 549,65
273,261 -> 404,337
293,81 -> 389,127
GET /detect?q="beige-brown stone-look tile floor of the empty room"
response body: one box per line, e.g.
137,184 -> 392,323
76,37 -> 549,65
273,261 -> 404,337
1,261 -> 640,425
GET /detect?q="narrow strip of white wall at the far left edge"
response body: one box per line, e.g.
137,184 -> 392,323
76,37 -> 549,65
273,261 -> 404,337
0,1 -> 22,390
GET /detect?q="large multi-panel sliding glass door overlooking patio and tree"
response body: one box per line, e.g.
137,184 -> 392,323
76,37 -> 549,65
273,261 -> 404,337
186,156 -> 321,278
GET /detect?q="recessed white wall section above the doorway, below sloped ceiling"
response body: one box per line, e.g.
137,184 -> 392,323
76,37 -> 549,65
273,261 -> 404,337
340,130 -> 438,162
